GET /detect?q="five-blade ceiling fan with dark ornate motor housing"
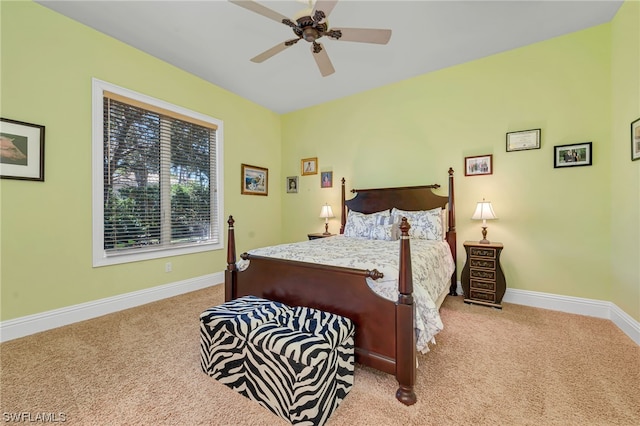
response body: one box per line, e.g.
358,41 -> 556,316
229,0 -> 391,77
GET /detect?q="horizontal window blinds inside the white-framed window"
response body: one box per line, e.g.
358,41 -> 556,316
103,91 -> 220,255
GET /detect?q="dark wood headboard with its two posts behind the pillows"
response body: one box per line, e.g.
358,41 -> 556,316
340,168 -> 457,295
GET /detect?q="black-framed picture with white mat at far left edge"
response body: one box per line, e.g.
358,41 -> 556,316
0,118 -> 44,182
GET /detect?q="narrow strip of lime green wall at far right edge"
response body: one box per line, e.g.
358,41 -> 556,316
609,1 -> 640,321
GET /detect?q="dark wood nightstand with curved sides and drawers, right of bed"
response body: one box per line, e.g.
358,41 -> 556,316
460,241 -> 507,309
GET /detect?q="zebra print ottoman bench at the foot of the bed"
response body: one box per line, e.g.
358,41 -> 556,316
200,296 -> 355,425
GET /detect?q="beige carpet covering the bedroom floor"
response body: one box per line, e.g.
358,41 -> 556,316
0,286 -> 640,426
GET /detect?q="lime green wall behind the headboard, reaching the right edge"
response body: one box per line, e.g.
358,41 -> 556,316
282,3 -> 640,319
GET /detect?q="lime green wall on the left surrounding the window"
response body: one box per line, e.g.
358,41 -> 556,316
0,1 -> 281,320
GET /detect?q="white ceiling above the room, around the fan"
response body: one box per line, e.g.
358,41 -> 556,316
38,0 -> 623,113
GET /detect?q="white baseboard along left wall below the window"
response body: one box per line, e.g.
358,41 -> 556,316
0,272 -> 224,342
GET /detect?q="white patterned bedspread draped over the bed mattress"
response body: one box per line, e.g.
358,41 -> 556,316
238,235 -> 454,353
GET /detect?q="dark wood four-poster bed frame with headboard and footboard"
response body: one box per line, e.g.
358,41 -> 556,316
225,168 -> 457,405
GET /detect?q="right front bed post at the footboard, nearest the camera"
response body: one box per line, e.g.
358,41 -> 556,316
396,217 -> 417,405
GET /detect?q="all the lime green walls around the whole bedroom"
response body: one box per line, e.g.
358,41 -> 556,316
0,1 -> 640,320
